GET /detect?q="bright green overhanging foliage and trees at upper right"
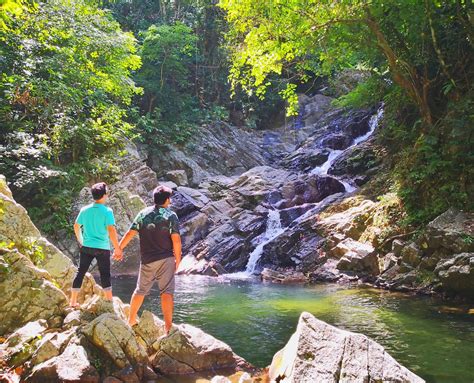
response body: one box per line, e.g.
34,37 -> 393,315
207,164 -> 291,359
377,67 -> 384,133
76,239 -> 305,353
219,0 -> 474,223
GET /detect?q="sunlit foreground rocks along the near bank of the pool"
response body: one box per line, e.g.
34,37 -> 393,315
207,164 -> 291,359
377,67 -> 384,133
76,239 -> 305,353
0,176 -> 423,383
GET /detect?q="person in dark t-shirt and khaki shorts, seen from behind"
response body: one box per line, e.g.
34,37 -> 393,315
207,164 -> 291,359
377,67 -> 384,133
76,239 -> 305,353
114,186 -> 181,335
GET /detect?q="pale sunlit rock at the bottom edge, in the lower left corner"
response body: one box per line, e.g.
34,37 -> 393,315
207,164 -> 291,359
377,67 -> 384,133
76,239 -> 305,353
26,342 -> 100,383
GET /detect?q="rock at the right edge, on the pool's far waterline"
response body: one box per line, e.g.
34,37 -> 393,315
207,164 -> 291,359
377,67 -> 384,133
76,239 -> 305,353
435,253 -> 474,298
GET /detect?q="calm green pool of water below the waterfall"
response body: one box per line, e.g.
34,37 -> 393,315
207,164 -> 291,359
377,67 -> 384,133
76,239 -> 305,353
113,276 -> 474,382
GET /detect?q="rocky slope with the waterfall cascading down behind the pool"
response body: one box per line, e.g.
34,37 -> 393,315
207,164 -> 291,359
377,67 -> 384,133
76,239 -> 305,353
42,94 -> 474,298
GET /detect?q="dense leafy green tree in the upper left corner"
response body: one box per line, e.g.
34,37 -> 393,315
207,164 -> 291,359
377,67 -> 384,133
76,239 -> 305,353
0,0 -> 140,228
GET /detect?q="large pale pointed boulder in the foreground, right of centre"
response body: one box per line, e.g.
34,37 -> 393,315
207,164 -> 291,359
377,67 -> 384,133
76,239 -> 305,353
269,312 -> 424,383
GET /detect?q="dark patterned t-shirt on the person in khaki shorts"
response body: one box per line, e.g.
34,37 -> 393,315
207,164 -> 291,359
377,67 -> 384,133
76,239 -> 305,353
130,206 -> 179,265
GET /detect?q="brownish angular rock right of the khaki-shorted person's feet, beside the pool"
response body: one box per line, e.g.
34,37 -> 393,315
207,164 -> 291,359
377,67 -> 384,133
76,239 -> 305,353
152,324 -> 250,375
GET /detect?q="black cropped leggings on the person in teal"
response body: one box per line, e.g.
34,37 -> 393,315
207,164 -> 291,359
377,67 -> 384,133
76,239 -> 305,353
72,246 -> 112,291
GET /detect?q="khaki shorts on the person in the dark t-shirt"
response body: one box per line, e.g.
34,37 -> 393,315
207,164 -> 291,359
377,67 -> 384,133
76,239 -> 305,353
134,257 -> 176,295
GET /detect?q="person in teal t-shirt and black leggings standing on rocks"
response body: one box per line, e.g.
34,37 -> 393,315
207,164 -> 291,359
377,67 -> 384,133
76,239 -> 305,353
70,182 -> 122,307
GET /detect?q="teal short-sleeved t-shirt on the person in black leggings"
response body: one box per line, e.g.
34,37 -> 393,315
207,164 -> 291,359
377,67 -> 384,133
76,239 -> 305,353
76,203 -> 115,250
